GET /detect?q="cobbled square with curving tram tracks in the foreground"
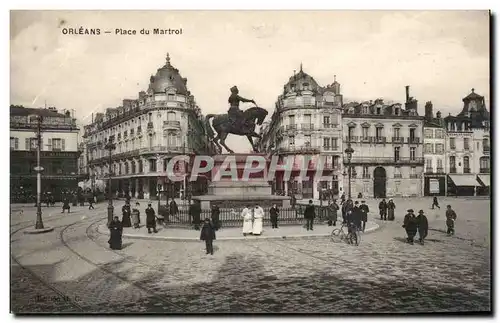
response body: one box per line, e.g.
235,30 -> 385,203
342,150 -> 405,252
11,199 -> 490,313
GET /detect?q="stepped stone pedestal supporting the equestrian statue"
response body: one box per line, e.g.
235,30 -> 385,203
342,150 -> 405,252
193,154 -> 290,209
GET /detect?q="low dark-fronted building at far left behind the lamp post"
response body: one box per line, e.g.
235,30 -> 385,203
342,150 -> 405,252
10,105 -> 80,203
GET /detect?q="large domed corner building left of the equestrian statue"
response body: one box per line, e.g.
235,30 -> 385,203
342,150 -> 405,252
80,54 -> 214,199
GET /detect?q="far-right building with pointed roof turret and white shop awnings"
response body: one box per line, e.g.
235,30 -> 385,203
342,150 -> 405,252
444,89 -> 491,195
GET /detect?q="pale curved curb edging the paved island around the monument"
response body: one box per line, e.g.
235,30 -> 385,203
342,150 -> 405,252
97,222 -> 380,242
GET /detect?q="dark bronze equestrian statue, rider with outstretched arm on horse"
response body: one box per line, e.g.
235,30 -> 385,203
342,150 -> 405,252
205,86 -> 268,154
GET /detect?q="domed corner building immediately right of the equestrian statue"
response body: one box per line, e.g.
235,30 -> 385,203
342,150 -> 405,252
260,65 -> 342,199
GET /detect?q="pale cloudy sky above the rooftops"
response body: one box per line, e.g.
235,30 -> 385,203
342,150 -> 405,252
10,11 -> 490,152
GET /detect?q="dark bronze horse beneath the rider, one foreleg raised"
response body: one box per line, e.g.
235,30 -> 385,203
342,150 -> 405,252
205,107 -> 268,154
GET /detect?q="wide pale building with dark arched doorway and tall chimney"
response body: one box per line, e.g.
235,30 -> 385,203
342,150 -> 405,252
342,86 -> 424,198
